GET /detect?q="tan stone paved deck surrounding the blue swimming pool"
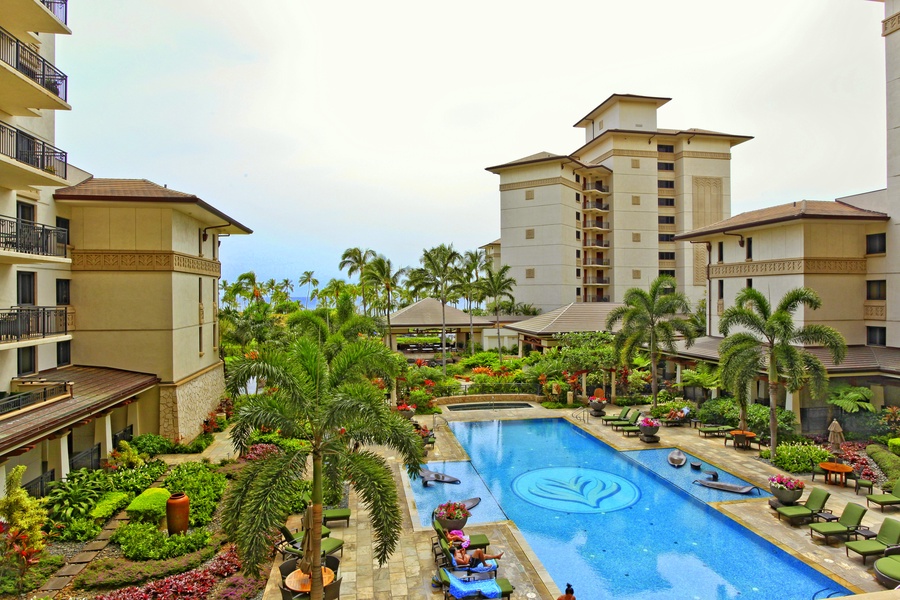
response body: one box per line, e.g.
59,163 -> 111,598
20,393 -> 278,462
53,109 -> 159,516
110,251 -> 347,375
264,405 -> 900,600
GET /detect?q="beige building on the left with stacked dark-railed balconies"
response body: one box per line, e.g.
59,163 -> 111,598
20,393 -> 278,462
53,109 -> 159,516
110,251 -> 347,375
0,0 -> 251,495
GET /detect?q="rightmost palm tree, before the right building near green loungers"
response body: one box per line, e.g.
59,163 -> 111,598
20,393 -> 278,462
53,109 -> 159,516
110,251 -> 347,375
719,287 -> 847,458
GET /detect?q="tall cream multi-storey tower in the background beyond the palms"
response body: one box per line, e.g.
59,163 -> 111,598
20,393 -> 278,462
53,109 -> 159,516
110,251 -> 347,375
484,94 -> 752,312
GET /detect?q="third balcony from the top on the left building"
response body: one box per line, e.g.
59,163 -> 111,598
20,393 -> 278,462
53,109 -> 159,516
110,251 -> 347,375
0,121 -> 68,190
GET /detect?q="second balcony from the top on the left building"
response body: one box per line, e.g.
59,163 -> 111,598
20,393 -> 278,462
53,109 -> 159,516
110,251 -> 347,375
0,28 -> 72,117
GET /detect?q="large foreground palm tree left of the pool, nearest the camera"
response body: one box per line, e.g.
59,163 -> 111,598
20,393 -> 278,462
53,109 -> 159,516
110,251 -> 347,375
224,337 -> 422,599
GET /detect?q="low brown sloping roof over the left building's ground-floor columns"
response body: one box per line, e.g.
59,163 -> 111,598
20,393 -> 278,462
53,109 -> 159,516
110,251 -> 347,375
0,366 -> 159,459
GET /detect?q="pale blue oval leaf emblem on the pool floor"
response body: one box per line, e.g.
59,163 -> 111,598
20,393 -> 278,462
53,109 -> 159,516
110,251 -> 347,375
512,467 -> 641,513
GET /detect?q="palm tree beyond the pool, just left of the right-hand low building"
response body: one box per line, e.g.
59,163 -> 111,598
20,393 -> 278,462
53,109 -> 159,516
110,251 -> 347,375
606,275 -> 694,408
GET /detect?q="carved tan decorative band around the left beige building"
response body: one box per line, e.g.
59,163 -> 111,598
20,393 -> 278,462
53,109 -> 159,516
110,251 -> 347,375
72,250 -> 222,277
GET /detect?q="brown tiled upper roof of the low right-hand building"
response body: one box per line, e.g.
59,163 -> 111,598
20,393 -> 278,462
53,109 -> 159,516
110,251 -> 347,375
675,200 -> 890,240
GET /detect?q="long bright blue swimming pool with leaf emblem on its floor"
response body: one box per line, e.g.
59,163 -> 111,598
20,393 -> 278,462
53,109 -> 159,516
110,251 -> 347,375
413,419 -> 852,600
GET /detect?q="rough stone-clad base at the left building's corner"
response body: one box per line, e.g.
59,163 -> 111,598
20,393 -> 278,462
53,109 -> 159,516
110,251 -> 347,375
159,363 -> 225,441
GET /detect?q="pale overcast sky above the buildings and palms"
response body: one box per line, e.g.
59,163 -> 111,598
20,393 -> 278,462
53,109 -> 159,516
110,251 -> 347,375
56,0 -> 885,286
